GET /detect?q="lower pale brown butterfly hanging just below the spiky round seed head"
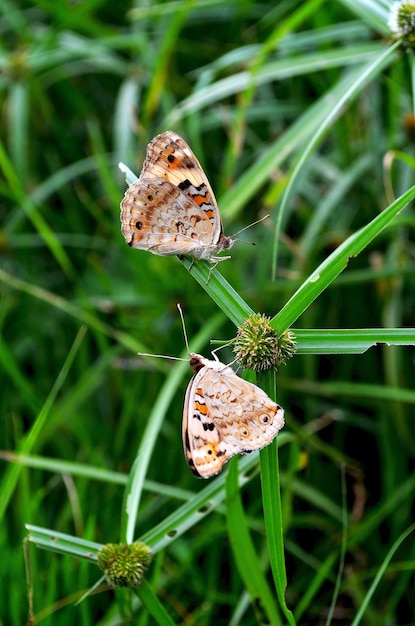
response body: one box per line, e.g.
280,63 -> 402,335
182,352 -> 284,478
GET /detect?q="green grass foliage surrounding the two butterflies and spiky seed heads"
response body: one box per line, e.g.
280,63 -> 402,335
0,0 -> 415,626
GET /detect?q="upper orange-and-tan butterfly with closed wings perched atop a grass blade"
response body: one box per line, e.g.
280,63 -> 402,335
121,130 -> 235,264
